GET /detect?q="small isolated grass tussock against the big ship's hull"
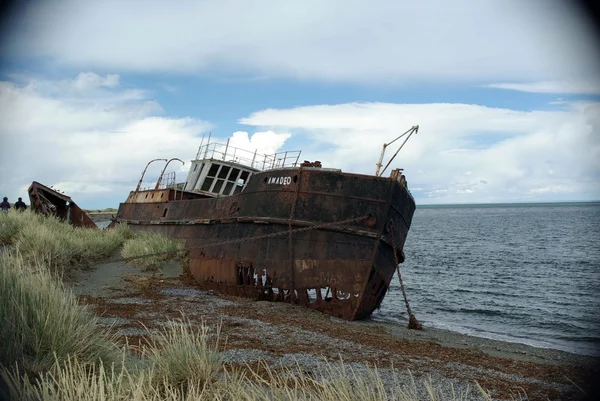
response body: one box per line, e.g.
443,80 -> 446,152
121,231 -> 185,269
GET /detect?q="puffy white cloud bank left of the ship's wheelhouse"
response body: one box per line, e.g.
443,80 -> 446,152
0,73 -> 211,207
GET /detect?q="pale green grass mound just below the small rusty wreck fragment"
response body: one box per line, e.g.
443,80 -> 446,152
0,210 -> 132,272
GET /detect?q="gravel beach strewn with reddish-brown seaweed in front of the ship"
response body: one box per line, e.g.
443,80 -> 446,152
68,262 -> 599,400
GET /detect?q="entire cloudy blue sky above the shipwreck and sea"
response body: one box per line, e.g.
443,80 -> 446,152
0,0 -> 600,209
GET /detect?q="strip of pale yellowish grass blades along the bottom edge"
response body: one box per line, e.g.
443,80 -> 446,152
3,346 -> 491,401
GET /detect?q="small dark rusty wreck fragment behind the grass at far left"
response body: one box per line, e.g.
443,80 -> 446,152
27,181 -> 98,229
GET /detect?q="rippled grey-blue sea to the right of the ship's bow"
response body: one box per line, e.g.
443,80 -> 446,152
372,203 -> 600,355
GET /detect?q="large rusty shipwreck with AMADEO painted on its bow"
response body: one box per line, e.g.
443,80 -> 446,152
113,126 -> 418,320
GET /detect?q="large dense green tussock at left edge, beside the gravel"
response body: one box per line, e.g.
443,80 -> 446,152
0,251 -> 118,374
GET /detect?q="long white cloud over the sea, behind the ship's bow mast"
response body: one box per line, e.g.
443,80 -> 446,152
240,102 -> 600,203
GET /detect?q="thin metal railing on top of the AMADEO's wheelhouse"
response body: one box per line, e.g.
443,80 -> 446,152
196,140 -> 301,171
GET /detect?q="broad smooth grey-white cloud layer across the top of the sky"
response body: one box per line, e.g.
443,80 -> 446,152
0,0 -> 600,86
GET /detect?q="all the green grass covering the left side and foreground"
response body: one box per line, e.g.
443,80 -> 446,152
0,213 -> 490,401
